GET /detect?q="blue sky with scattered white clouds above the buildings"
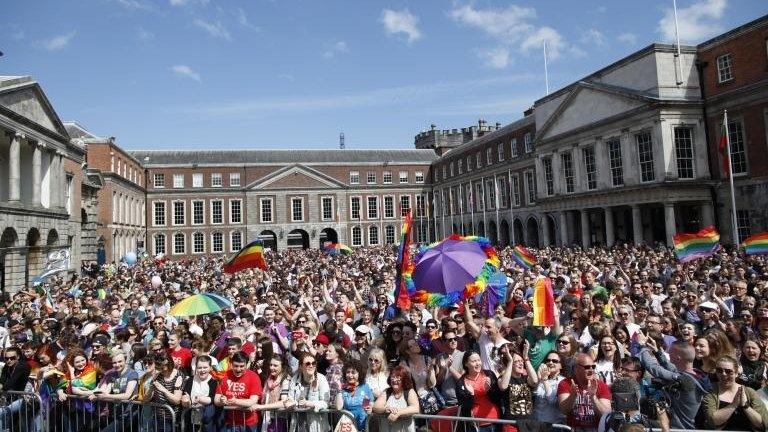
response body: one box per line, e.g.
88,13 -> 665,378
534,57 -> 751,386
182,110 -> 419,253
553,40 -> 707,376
0,0 -> 768,149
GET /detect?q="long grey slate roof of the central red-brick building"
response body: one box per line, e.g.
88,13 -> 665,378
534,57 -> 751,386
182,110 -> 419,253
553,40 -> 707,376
128,149 -> 437,167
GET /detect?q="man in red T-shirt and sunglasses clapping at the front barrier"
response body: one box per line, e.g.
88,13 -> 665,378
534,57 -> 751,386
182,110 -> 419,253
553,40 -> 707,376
557,353 -> 611,431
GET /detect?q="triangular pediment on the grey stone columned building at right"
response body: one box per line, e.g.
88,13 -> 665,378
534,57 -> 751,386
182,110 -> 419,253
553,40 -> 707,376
537,83 -> 649,140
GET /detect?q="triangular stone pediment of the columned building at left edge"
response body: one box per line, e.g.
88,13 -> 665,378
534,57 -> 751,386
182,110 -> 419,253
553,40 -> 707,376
0,83 -> 68,136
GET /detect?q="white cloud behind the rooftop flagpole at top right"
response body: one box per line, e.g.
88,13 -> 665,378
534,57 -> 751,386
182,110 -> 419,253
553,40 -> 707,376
656,0 -> 727,43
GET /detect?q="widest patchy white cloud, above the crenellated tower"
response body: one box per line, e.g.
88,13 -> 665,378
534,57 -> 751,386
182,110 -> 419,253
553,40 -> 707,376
448,5 -> 570,68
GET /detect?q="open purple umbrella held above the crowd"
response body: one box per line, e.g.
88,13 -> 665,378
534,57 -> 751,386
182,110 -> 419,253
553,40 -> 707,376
413,239 -> 488,294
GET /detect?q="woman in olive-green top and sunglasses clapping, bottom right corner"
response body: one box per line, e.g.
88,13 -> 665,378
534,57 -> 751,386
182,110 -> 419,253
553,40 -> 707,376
701,355 -> 768,431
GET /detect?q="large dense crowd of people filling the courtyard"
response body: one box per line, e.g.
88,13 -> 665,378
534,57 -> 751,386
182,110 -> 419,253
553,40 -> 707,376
0,245 -> 768,432
